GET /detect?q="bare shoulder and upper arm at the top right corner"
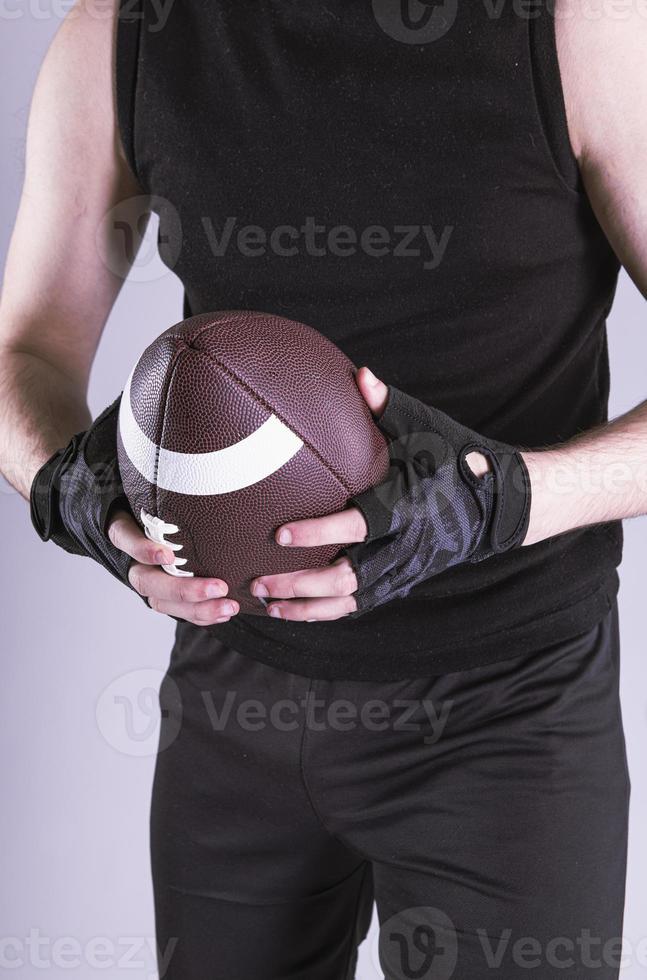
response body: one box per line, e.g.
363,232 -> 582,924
555,0 -> 647,296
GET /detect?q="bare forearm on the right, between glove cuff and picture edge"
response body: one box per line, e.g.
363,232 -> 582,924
522,401 -> 647,545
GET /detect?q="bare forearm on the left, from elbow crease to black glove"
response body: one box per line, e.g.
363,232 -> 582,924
0,348 -> 91,498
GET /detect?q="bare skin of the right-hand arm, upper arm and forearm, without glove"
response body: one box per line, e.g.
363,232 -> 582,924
524,0 -> 647,544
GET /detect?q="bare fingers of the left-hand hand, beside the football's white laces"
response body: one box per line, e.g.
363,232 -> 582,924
108,510 -> 239,626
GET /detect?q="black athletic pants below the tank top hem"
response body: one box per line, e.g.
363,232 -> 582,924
152,609 -> 629,980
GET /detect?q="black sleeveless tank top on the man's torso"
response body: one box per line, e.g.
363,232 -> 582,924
117,0 -> 621,679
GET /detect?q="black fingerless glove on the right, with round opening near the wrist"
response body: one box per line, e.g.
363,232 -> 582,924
344,387 -> 530,616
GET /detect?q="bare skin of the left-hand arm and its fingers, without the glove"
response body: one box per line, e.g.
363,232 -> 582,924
0,0 -> 237,624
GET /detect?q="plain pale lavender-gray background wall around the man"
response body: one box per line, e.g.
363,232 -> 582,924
0,9 -> 647,980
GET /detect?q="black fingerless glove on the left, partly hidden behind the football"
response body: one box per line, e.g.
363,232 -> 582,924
30,398 -> 132,585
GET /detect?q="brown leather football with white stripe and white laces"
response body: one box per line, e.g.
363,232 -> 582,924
118,311 -> 388,615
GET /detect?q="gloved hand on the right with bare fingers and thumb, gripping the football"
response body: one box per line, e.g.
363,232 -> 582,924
251,368 -> 530,622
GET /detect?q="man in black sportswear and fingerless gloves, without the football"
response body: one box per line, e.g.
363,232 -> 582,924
0,0 -> 647,980
